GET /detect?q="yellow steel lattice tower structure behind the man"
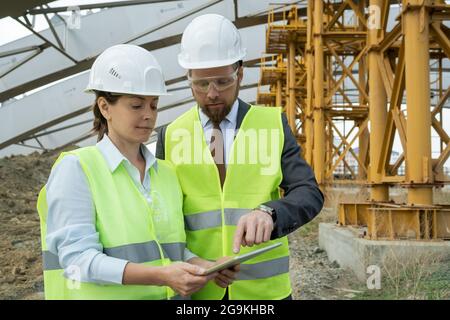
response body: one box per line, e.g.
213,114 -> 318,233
258,0 -> 450,239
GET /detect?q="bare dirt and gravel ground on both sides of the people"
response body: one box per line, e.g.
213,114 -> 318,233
0,151 -> 450,300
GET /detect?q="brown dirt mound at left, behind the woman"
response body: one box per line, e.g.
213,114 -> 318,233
0,147 -> 75,299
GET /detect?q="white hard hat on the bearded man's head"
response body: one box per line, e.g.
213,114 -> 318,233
178,14 -> 246,69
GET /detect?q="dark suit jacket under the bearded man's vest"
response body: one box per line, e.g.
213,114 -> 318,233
156,99 -> 324,239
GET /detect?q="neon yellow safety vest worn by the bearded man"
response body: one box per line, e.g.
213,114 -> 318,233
165,106 -> 291,300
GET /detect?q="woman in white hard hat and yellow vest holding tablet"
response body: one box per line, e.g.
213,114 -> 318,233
38,45 -> 236,299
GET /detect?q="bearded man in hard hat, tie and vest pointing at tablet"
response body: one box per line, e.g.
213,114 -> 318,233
156,14 -> 323,300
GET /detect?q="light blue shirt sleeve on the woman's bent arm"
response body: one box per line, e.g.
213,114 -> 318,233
46,155 -> 128,284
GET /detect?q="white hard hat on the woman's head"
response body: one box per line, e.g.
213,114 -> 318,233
85,44 -> 168,96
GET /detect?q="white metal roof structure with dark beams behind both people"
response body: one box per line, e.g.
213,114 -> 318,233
0,0 -> 312,157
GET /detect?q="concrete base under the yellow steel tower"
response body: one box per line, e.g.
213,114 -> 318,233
319,223 -> 450,282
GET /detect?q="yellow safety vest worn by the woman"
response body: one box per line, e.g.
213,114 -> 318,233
37,146 -> 186,300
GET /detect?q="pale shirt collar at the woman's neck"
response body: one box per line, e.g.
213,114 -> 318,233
96,134 -> 158,172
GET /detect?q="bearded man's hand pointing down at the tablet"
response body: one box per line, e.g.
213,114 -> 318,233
233,210 -> 273,253
